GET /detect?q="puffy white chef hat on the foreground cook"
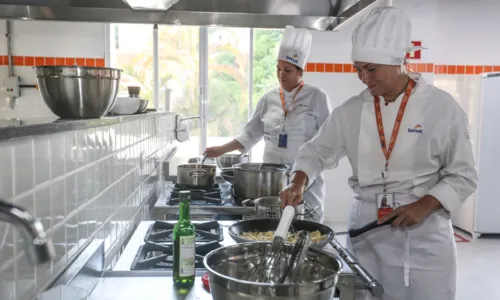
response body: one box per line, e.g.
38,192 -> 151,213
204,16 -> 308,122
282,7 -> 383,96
351,6 -> 425,65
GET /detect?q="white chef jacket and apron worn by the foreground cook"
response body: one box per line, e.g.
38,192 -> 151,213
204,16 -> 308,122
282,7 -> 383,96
293,73 -> 478,300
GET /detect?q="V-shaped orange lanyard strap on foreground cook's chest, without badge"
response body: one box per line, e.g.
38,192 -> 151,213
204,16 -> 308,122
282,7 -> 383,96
374,79 -> 416,176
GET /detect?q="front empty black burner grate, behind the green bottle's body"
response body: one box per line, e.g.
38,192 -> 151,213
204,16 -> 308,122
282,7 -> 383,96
130,241 -> 221,270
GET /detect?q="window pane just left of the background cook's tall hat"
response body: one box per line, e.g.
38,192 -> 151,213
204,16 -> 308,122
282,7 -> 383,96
206,27 -> 250,147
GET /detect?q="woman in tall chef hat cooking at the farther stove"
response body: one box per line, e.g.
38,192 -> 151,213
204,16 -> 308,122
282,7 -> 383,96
205,26 -> 331,222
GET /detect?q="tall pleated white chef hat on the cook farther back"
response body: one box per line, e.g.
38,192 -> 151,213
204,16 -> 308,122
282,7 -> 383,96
278,26 -> 312,69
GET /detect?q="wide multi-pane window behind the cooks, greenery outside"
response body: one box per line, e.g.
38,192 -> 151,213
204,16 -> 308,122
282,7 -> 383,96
109,24 -> 283,175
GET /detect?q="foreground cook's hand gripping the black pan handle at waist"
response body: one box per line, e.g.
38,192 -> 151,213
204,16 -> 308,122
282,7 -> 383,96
378,195 -> 443,227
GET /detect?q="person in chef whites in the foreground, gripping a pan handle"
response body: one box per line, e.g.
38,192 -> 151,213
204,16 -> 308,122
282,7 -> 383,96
280,7 -> 478,300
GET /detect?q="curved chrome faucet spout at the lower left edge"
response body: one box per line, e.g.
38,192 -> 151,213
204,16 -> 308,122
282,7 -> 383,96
0,199 -> 55,265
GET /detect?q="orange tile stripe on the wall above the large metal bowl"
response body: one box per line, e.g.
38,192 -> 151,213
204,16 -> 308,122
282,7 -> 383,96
0,55 -> 106,67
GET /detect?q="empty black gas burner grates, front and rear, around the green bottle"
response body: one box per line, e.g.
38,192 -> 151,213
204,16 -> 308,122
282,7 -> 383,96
130,221 -> 224,270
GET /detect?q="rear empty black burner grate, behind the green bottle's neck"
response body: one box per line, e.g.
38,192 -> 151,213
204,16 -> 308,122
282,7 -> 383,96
144,221 -> 224,243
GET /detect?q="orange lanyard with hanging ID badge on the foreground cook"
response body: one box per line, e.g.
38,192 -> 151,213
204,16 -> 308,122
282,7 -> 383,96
374,79 -> 416,220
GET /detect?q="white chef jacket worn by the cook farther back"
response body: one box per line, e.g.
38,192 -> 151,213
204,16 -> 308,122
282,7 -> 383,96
236,83 -> 332,222
